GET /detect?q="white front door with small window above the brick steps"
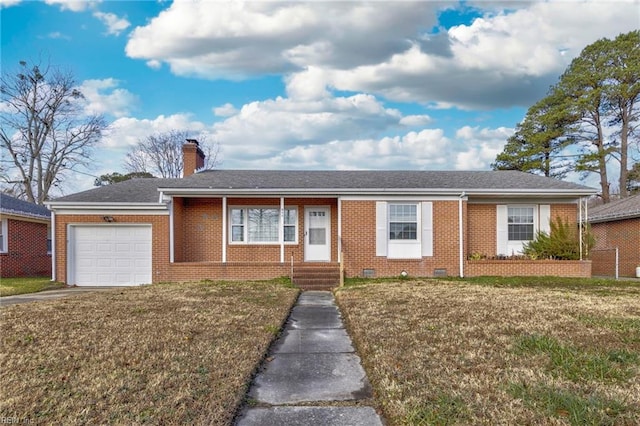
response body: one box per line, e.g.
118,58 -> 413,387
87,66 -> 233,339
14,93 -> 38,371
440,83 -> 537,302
304,207 -> 331,262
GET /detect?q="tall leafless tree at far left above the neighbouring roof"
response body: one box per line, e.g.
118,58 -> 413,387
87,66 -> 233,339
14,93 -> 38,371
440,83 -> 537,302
0,61 -> 107,204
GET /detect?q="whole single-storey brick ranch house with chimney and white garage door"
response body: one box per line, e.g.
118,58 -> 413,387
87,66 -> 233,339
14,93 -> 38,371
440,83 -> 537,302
49,143 -> 594,286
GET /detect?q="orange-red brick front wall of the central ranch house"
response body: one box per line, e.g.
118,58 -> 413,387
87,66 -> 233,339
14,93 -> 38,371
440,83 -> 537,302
56,198 -> 590,282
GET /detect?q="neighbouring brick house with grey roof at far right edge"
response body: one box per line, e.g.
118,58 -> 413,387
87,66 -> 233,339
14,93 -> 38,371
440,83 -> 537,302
588,194 -> 640,277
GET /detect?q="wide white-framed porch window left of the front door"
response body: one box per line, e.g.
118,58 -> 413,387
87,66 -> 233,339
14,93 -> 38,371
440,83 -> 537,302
229,207 -> 298,244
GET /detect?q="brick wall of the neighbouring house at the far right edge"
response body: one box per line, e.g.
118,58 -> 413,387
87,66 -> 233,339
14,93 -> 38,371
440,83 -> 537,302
591,218 -> 640,277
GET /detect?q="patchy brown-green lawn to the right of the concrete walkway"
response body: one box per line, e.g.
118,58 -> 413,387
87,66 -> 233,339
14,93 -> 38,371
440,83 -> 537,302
337,278 -> 640,425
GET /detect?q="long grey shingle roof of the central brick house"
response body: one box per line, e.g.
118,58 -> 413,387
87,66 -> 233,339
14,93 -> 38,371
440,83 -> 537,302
51,170 -> 596,204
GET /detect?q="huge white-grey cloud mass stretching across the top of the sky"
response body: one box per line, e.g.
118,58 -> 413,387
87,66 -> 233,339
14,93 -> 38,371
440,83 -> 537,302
126,1 -> 638,109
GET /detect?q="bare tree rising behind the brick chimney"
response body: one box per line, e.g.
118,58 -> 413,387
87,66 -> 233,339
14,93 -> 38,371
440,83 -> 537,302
124,130 -> 220,178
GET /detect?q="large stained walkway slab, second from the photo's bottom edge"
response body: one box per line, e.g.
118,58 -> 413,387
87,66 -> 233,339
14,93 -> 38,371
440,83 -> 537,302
249,353 -> 371,405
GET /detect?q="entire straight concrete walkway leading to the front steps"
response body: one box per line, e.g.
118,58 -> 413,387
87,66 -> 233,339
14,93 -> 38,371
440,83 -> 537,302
236,291 -> 383,426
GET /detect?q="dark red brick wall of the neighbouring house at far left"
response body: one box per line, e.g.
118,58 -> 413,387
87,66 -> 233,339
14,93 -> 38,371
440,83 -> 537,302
0,218 -> 51,278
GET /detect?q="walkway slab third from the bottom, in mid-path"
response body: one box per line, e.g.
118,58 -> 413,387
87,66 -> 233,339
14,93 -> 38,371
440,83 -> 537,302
273,328 -> 355,354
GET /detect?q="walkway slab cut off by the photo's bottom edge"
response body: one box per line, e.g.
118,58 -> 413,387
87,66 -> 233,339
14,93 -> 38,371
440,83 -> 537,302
237,407 -> 383,426
